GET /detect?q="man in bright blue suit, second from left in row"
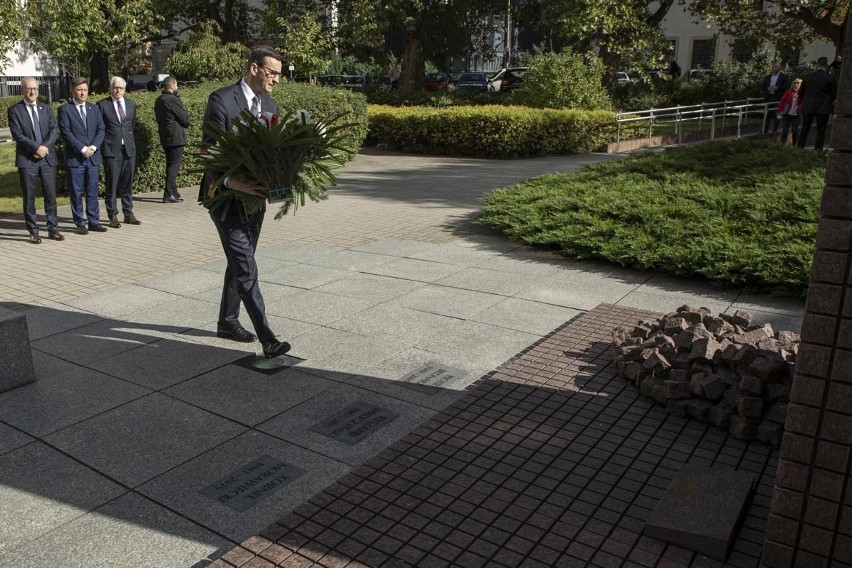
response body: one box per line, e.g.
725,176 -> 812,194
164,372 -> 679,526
59,77 -> 107,235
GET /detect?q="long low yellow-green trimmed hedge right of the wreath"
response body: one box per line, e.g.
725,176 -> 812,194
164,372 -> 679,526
365,105 -> 640,158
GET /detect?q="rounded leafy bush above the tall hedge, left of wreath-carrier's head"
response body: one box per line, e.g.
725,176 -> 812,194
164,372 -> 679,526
166,21 -> 248,81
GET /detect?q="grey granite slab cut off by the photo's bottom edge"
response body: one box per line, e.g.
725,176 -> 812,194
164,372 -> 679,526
0,493 -> 231,568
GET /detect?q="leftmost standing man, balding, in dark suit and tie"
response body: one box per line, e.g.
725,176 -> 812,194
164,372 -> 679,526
7,77 -> 65,245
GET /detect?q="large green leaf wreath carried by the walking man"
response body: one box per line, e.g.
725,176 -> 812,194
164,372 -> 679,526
200,109 -> 351,219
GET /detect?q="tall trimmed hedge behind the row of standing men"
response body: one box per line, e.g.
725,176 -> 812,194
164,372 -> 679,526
0,82 -> 367,193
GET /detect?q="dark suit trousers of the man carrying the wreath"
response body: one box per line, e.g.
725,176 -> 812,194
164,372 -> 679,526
210,206 -> 275,341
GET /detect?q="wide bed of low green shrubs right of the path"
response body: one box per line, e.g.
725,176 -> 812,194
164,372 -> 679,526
479,140 -> 826,295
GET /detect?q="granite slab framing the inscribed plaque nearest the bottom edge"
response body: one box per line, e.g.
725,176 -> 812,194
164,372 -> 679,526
139,431 -> 350,542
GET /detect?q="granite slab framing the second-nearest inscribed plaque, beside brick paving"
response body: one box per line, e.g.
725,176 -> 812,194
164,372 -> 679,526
257,384 -> 435,465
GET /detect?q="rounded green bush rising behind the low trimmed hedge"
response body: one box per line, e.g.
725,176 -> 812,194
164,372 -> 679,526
513,50 -> 612,109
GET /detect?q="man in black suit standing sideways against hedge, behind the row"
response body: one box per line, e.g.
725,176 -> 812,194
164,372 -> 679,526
154,75 -> 189,203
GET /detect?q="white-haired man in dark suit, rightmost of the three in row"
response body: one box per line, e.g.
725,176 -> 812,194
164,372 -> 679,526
98,77 -> 141,229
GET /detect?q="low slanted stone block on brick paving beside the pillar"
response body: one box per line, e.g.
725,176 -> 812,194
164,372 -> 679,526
643,464 -> 755,560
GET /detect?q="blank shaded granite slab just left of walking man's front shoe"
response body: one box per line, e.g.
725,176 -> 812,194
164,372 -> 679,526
91,336 -> 246,390
